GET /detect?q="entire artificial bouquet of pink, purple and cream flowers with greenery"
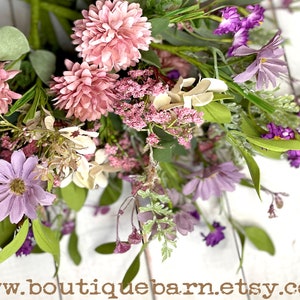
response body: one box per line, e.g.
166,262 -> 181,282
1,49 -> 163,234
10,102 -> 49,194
0,0 -> 300,279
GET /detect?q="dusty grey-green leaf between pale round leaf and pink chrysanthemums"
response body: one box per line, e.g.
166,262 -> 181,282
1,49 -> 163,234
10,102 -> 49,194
29,50 -> 56,84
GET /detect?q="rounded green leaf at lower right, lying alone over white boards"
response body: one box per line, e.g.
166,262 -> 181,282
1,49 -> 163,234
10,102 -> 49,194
244,226 -> 275,255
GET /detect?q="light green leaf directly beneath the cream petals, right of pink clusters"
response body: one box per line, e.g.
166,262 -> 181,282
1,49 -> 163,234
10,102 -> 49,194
196,102 -> 231,123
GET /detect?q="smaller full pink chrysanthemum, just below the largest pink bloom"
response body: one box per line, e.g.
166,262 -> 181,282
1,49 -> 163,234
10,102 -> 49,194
50,60 -> 118,122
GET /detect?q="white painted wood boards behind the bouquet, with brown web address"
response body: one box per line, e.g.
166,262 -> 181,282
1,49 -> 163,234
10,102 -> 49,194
0,0 -> 300,300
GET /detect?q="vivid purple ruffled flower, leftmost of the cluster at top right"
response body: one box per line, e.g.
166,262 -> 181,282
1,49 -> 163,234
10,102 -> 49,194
214,7 -> 241,35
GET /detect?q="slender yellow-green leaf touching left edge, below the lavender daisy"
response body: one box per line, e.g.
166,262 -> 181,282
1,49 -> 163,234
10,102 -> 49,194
0,219 -> 29,263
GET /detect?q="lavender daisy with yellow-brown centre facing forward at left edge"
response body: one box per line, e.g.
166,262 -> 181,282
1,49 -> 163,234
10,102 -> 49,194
0,150 -> 55,223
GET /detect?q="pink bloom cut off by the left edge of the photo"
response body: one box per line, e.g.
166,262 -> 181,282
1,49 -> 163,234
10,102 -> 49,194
0,63 -> 22,114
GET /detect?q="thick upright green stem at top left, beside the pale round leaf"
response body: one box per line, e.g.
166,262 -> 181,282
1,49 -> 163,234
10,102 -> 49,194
30,0 -> 41,50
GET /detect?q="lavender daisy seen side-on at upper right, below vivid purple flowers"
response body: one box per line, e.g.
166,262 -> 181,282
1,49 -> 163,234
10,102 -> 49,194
233,31 -> 287,90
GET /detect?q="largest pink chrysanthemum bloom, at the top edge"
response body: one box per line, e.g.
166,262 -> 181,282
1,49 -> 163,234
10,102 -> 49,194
71,0 -> 151,71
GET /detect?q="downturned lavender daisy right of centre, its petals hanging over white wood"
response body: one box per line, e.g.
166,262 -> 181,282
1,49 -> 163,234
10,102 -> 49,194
183,161 -> 244,200
